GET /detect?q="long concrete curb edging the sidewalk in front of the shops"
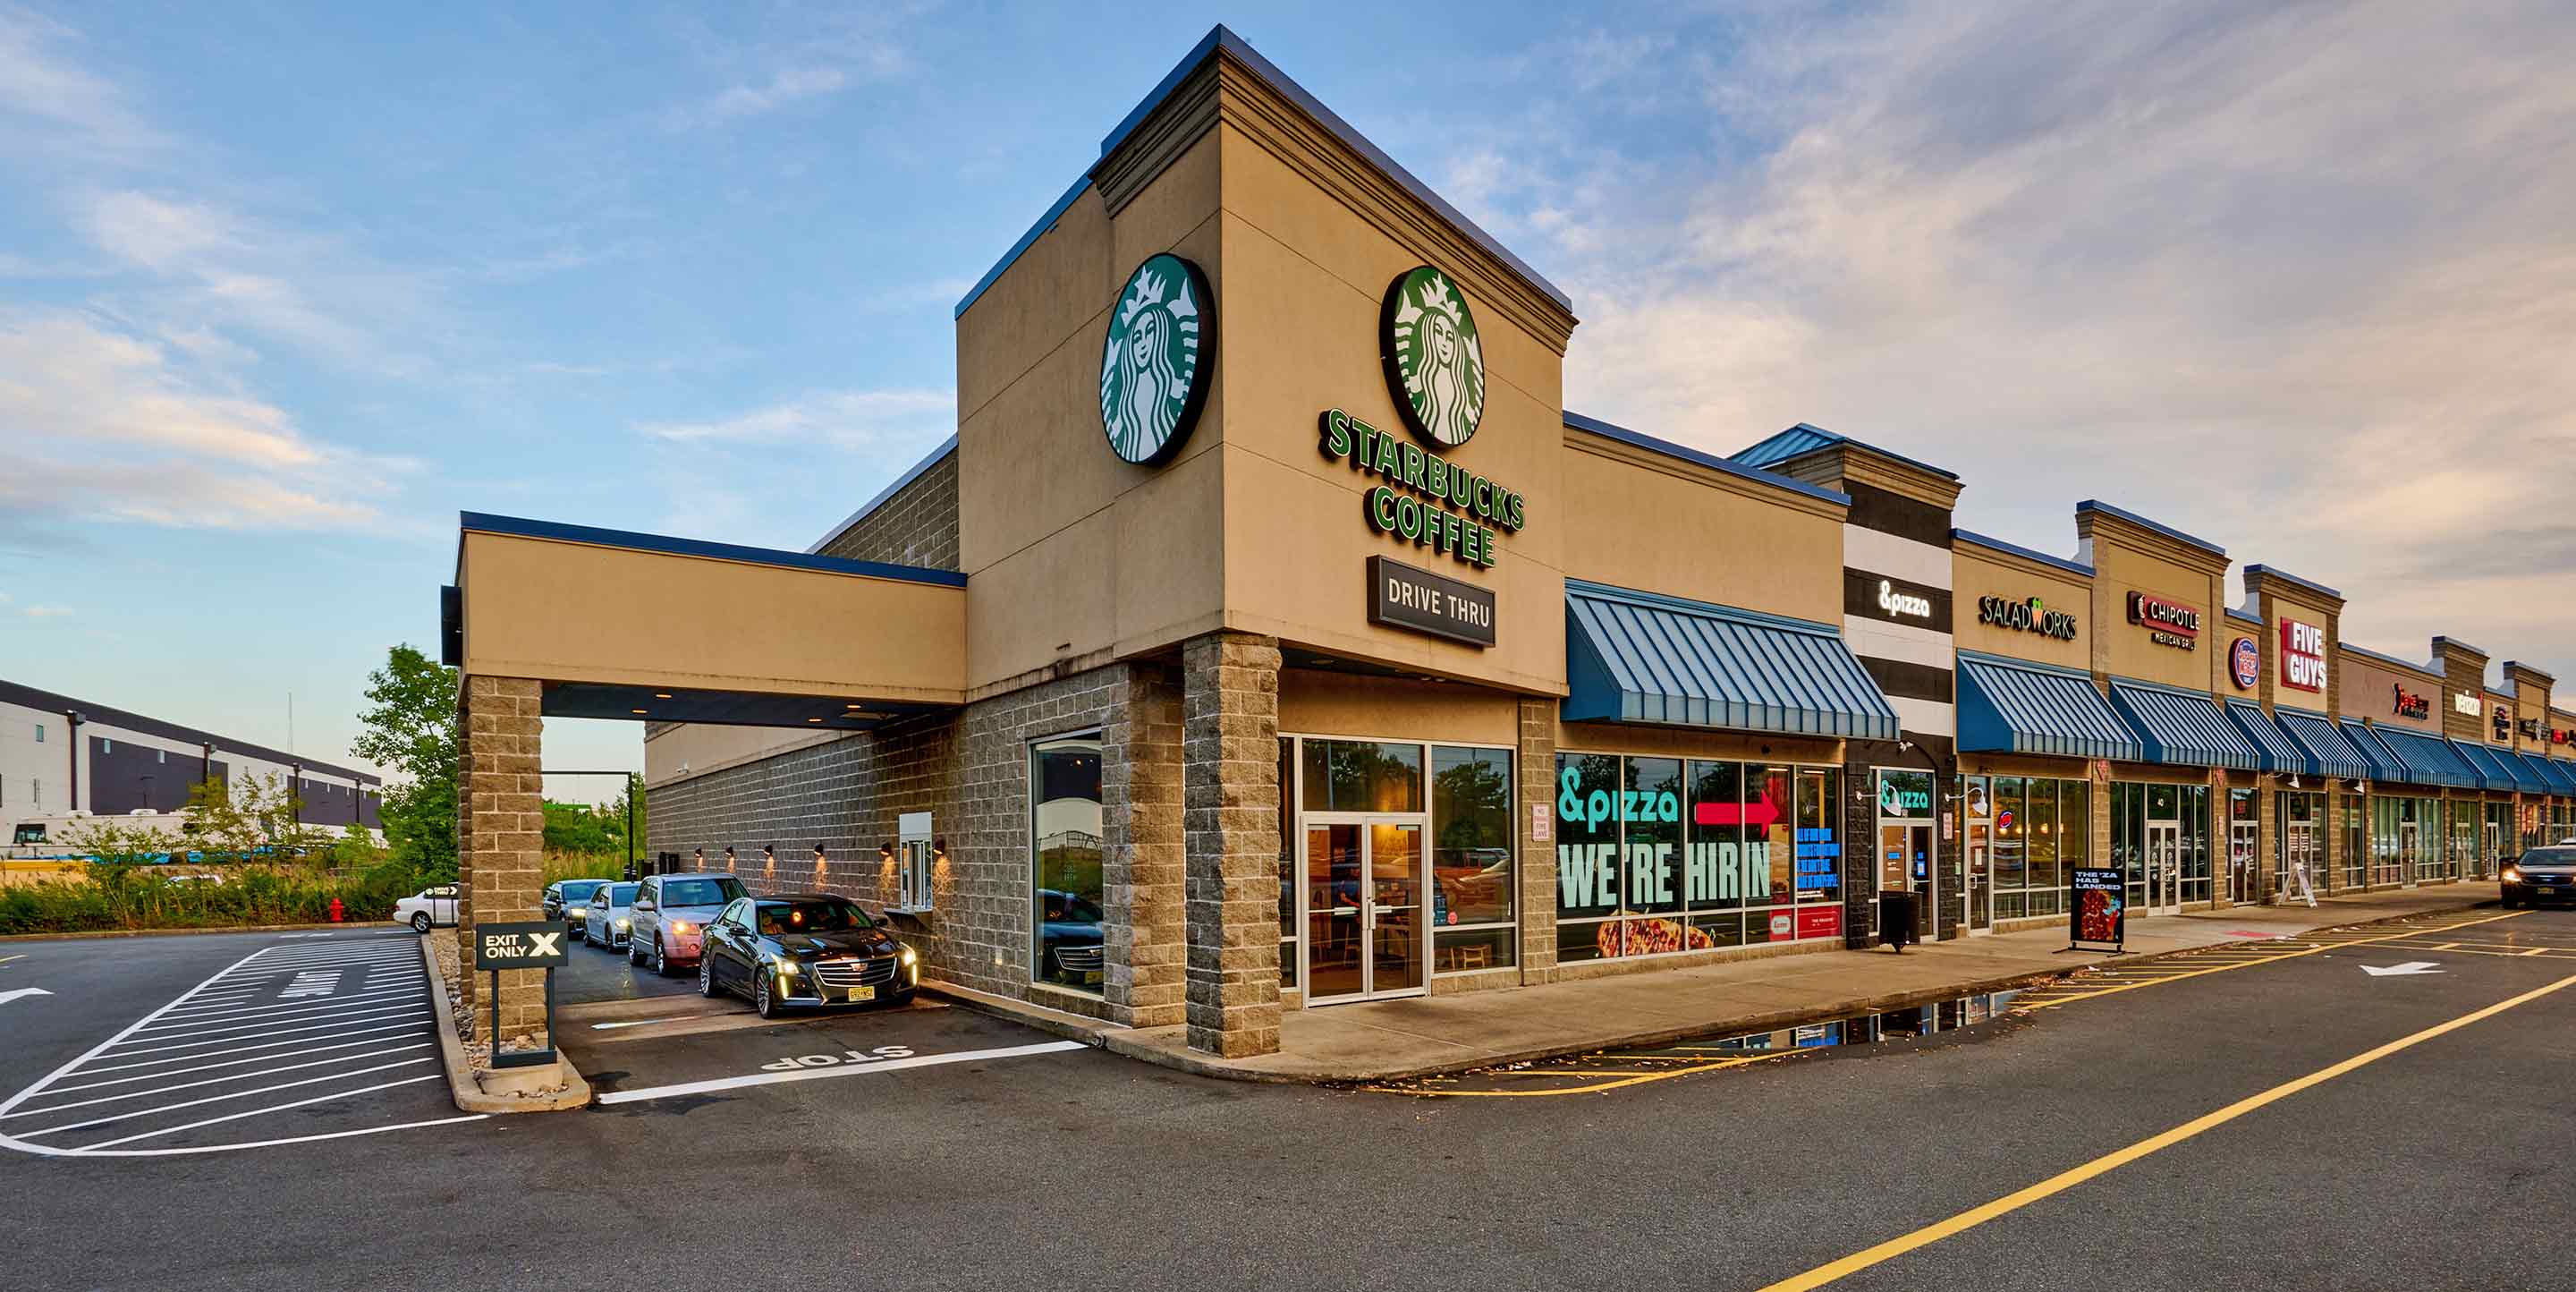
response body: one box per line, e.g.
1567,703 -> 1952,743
1051,900 -> 2483,1085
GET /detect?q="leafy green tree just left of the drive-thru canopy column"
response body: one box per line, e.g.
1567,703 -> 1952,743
351,645 -> 456,882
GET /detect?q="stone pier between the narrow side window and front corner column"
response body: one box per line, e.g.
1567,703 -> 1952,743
1100,663 -> 1190,1026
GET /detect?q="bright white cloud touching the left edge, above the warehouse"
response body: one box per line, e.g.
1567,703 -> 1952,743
0,312 -> 407,536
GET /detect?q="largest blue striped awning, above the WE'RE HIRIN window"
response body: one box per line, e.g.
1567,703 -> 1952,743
1558,578 -> 1896,740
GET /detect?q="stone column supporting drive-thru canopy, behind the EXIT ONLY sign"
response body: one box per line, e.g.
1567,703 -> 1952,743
456,676 -> 547,1044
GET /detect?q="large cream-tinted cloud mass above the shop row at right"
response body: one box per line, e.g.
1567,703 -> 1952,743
1453,0 -> 2576,667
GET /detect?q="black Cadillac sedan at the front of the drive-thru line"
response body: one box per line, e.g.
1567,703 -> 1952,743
698,892 -> 922,1018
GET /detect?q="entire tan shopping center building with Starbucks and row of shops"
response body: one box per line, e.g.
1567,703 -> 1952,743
445,29 -> 2576,1055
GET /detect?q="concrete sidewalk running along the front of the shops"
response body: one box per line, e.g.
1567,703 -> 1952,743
927,882 -> 2496,1084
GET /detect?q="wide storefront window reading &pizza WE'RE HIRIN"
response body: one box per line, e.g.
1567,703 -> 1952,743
1556,753 -> 1842,962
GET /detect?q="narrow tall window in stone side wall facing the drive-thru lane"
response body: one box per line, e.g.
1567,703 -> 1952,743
1028,735 -> 1103,993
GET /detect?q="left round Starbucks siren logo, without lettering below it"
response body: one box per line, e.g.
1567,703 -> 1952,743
1100,252 -> 1216,464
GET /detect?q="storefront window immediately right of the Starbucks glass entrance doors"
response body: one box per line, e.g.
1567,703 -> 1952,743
1432,745 -> 1514,973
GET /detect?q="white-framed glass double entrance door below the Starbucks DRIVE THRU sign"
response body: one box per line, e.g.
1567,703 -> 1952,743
1303,812 -> 1429,1006
